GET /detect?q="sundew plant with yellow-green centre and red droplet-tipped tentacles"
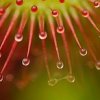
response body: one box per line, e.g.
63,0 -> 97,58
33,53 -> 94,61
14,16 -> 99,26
0,0 -> 100,86
